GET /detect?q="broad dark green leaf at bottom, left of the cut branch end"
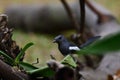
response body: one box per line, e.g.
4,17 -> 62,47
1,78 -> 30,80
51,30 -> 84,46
27,66 -> 55,77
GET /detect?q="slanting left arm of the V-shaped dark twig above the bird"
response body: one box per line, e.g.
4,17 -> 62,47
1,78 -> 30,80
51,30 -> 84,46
60,0 -> 80,33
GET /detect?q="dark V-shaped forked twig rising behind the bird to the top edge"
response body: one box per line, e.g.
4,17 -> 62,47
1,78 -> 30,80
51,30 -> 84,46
61,0 -> 86,44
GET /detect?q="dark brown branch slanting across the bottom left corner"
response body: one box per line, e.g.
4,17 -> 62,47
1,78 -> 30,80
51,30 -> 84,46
0,60 -> 31,80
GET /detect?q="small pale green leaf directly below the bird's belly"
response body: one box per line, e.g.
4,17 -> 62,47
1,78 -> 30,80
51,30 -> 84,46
61,55 -> 77,67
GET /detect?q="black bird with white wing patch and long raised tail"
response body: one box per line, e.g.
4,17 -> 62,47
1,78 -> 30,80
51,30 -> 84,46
53,35 -> 100,56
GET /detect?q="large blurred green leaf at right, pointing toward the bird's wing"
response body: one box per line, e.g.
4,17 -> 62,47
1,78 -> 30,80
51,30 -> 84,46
78,32 -> 120,54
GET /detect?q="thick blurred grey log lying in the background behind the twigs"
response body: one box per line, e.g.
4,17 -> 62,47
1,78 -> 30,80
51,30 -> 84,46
4,1 -> 117,33
